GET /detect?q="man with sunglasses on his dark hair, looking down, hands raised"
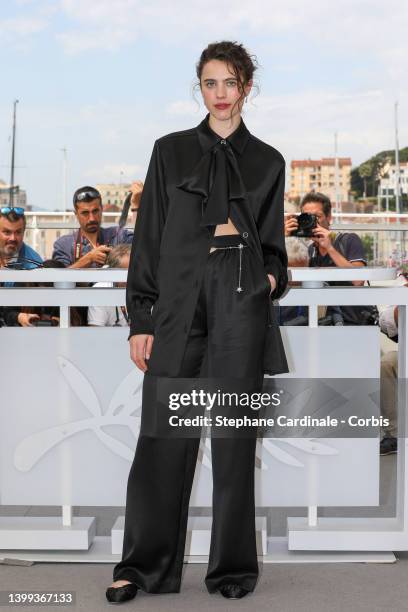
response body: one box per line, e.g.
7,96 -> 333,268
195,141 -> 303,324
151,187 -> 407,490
52,186 -> 133,268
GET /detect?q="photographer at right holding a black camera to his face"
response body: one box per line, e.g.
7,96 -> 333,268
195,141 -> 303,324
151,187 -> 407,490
285,192 -> 373,325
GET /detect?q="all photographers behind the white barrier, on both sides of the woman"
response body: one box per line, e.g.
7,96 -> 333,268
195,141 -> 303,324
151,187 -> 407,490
0,181 -> 406,454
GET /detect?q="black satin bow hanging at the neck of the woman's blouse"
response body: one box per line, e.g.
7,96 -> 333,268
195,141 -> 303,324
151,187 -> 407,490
177,139 -> 245,226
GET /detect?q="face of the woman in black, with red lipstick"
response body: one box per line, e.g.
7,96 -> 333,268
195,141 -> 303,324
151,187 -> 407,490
200,60 -> 252,121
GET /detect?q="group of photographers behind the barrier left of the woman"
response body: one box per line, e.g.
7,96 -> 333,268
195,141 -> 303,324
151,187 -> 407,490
0,181 -> 143,327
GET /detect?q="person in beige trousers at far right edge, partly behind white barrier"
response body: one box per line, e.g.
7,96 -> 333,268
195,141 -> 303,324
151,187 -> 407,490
378,273 -> 408,455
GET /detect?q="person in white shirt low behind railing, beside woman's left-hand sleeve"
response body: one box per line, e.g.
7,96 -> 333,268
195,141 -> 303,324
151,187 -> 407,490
88,244 -> 131,327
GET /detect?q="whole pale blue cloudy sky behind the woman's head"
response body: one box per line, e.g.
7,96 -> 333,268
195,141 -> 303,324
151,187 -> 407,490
0,0 -> 408,210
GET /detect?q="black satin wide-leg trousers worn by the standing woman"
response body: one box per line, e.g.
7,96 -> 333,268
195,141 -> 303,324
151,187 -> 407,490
113,235 -> 270,593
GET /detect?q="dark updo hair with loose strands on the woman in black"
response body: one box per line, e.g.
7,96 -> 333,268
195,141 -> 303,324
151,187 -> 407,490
196,40 -> 258,117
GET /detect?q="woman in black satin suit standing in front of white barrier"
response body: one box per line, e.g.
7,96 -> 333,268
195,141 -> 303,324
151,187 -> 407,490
106,42 -> 288,602
